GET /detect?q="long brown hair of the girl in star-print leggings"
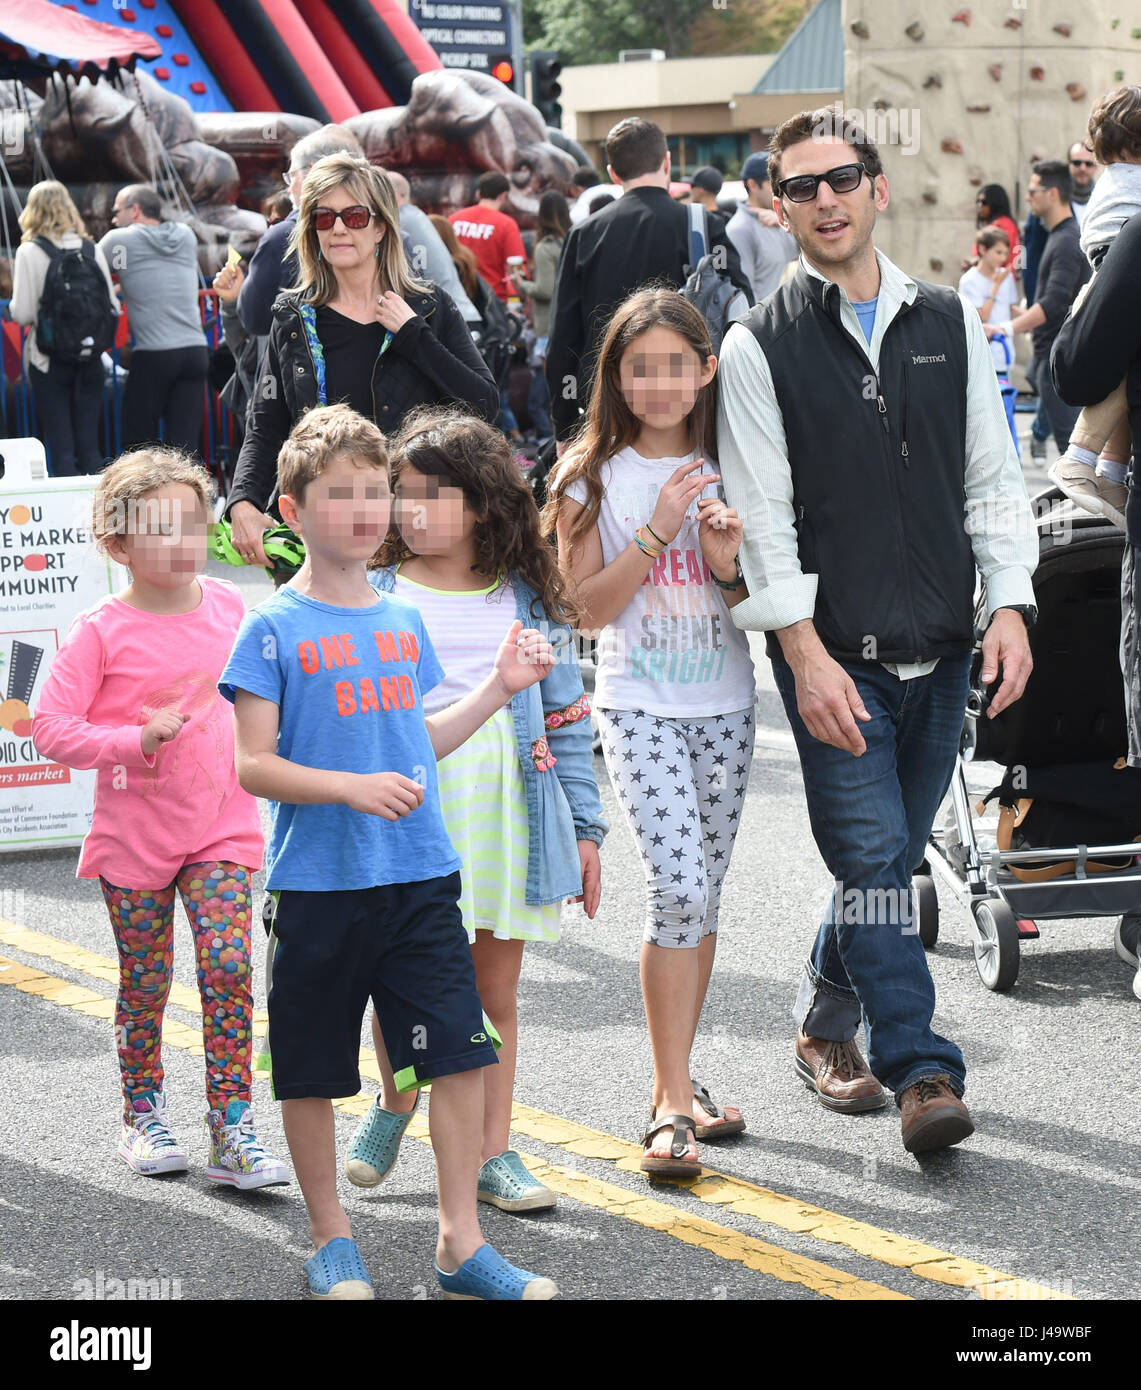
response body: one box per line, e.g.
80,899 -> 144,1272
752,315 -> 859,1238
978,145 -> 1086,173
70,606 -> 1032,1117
542,285 -> 717,541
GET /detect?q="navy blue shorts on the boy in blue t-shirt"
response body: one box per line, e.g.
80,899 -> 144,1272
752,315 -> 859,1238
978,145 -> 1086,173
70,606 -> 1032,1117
270,872 -> 499,1101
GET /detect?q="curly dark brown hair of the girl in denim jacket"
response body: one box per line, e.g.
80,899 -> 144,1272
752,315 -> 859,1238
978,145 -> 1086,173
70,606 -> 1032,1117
368,406 -> 578,626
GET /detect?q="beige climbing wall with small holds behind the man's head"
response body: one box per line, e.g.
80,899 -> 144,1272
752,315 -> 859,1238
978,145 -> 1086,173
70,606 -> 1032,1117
844,0 -> 1141,285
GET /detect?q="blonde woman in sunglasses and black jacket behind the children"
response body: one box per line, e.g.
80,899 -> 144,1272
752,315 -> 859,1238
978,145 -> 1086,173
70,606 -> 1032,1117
227,153 -> 499,566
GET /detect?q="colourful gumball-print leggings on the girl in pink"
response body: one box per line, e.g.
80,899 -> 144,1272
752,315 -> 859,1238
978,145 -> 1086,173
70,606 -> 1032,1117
99,863 -> 253,1111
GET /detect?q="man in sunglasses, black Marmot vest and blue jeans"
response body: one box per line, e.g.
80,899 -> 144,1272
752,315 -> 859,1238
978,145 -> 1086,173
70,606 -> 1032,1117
717,108 -> 1038,1152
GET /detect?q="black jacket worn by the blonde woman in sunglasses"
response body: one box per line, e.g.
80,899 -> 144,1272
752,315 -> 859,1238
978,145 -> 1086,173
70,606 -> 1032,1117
227,286 -> 499,514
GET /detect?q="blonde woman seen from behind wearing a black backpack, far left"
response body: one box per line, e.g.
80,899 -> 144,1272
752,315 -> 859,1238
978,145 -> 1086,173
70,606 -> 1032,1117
11,179 -> 118,478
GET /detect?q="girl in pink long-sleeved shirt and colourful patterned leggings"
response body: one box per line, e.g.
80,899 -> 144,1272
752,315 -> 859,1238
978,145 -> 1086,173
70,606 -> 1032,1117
32,448 -> 289,1190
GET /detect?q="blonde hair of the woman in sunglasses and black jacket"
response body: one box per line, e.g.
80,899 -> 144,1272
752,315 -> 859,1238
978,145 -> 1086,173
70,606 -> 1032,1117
289,152 -> 431,307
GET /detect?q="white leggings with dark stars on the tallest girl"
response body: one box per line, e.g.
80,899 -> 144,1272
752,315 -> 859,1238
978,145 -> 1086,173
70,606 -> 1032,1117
596,706 -> 756,948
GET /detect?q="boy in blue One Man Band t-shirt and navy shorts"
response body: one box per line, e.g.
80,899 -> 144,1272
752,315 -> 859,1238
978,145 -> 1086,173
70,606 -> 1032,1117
218,406 -> 557,1300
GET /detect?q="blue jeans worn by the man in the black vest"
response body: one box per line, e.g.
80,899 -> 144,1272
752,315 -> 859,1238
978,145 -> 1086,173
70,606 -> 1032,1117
773,656 -> 970,1097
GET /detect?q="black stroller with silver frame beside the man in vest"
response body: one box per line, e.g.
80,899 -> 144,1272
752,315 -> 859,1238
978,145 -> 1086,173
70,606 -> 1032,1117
912,491 -> 1141,990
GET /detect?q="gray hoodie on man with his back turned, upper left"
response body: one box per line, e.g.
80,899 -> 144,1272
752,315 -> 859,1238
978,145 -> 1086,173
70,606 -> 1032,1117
99,222 -> 206,352
